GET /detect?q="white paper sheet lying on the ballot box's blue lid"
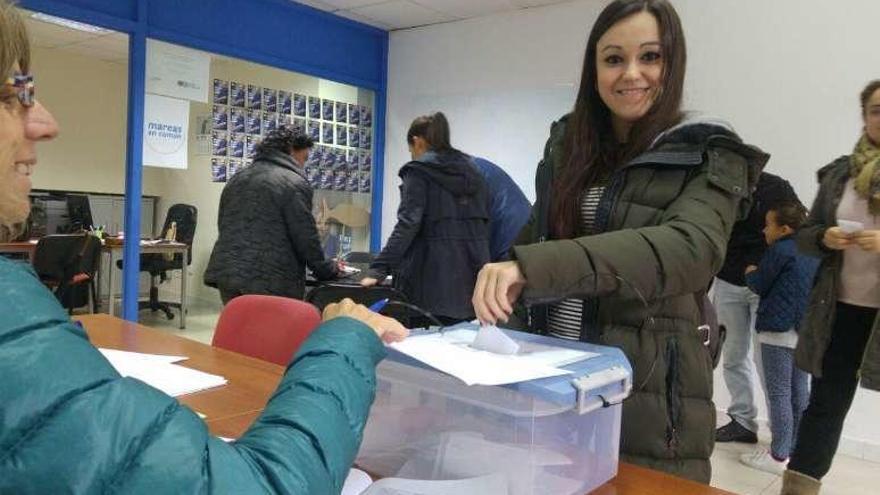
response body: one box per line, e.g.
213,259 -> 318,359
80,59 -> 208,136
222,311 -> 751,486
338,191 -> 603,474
391,330 -> 571,385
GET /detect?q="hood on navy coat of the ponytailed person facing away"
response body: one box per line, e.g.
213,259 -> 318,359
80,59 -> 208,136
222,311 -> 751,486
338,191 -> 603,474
399,150 -> 483,196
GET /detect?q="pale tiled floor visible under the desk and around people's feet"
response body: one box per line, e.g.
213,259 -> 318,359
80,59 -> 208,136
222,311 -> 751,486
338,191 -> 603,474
132,301 -> 880,495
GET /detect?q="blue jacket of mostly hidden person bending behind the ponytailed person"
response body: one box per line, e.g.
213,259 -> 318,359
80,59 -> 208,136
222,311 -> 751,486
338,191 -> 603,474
473,157 -> 532,263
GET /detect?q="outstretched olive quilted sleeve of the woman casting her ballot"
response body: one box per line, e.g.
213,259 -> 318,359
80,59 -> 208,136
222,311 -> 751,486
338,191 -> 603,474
514,146 -> 750,301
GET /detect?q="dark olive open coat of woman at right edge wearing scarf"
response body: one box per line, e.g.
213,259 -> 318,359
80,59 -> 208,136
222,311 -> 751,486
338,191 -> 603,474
795,156 -> 880,390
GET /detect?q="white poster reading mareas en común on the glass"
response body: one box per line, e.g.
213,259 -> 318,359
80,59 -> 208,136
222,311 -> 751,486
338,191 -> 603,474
143,94 -> 189,169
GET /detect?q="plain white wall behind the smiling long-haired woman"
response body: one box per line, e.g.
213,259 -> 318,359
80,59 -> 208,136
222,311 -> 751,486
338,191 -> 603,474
382,0 -> 880,461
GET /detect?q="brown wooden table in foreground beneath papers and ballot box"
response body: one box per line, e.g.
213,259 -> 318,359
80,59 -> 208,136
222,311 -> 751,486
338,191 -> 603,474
75,314 -> 731,495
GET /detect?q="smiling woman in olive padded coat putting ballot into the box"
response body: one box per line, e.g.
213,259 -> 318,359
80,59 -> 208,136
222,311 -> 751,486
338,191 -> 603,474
473,0 -> 767,482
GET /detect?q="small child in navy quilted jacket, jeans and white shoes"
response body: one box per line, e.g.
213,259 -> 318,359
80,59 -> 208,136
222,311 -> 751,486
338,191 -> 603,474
740,202 -> 819,475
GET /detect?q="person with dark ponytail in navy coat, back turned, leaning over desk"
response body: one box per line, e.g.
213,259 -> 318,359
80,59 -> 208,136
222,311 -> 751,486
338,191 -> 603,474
361,112 -> 490,324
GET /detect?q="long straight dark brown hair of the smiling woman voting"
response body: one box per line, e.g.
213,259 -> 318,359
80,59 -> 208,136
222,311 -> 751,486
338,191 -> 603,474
550,0 -> 687,239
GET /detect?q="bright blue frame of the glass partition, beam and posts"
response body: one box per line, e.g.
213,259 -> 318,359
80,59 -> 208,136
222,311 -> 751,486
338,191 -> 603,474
21,0 -> 388,321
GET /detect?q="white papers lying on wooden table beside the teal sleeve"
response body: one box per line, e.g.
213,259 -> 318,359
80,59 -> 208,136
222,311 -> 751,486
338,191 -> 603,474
99,349 -> 226,397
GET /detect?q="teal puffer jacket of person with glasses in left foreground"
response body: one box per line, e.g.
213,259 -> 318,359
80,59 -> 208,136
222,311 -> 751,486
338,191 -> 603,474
0,258 -> 384,495
